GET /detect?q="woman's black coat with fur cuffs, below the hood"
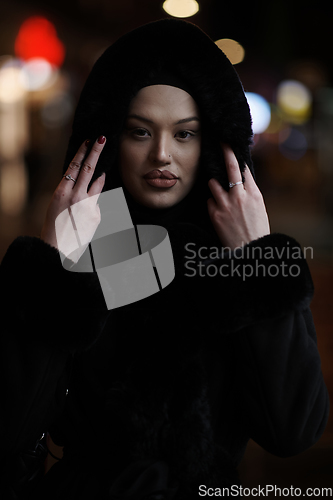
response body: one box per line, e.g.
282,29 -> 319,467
1,223 -> 328,500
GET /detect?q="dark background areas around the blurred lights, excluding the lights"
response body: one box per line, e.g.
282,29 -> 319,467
0,0 -> 333,496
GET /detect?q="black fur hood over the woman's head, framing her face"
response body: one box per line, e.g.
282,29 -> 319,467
64,19 -> 253,197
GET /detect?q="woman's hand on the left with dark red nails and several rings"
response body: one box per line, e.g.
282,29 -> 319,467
41,136 -> 105,256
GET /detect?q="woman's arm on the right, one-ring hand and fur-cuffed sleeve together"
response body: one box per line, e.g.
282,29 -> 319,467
208,145 -> 329,456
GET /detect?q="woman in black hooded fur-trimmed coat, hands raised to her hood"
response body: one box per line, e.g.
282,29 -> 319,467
1,19 -> 328,500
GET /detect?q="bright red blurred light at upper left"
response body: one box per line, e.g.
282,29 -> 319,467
15,16 -> 65,67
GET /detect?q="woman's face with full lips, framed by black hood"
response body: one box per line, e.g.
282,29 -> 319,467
119,85 -> 201,209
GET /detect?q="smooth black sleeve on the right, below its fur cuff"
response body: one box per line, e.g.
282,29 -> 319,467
233,308 -> 329,457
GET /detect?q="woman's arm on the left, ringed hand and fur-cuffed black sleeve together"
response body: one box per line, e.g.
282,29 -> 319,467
0,134 -> 109,464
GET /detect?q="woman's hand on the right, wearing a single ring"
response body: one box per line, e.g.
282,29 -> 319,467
207,144 -> 270,250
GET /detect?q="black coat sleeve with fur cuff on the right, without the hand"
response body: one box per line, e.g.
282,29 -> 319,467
201,234 -> 329,456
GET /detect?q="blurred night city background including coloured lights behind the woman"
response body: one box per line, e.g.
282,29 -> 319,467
0,0 -> 333,494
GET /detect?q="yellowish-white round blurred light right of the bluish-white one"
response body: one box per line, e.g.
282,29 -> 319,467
276,80 -> 312,124
